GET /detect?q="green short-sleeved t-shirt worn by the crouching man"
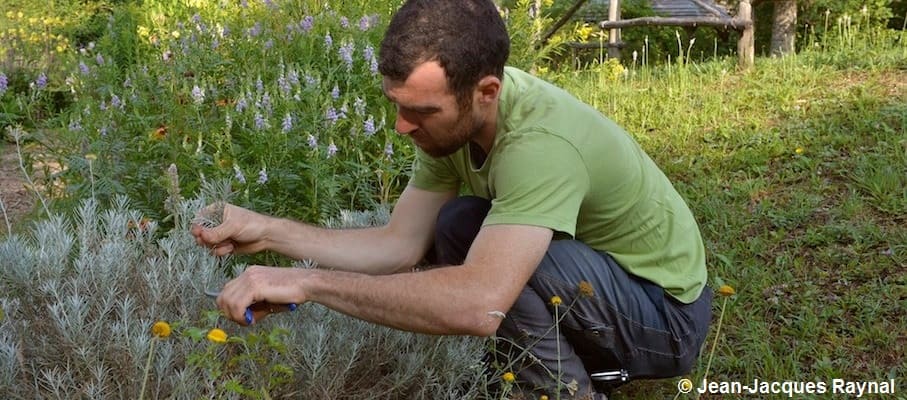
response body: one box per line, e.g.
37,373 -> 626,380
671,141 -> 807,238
410,67 -> 706,303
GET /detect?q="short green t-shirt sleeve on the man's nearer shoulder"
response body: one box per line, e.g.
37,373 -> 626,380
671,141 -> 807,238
484,132 -> 589,237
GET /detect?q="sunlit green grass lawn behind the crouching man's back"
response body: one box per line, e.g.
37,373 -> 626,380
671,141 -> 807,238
560,50 -> 907,399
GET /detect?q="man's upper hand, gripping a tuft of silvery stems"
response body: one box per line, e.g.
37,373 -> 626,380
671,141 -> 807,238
190,204 -> 274,256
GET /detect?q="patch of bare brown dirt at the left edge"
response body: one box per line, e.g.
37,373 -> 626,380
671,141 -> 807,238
0,144 -> 35,228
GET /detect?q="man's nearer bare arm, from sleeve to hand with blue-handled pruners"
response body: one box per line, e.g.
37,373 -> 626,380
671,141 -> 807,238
219,225 -> 552,336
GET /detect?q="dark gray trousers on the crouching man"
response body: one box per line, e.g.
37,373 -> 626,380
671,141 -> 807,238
428,197 -> 712,398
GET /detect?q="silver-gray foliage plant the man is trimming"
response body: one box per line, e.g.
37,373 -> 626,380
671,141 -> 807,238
0,198 -> 482,399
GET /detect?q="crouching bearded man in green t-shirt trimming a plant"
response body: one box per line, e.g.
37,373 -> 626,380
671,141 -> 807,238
192,0 -> 711,398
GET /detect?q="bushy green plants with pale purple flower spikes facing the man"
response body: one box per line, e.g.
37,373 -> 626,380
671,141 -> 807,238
39,1 -> 411,225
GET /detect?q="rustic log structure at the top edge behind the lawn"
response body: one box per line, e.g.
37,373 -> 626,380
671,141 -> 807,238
542,0 -> 755,68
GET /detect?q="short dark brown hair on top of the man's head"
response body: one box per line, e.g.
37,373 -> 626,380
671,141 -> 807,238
378,0 -> 510,105
